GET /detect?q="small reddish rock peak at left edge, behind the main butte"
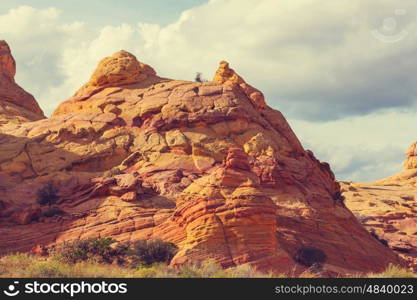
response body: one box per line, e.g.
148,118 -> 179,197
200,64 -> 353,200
0,40 -> 45,125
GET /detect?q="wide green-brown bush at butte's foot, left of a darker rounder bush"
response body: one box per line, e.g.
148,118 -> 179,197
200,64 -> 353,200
52,238 -> 119,264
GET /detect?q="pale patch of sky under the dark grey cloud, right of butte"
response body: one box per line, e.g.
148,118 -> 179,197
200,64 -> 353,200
290,110 -> 417,181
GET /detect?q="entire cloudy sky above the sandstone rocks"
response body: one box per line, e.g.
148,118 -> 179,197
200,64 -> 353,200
0,0 -> 417,181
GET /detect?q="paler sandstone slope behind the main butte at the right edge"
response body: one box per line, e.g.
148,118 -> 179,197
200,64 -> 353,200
342,143 -> 417,271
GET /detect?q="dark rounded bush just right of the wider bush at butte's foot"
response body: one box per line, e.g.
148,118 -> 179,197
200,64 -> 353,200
129,239 -> 178,265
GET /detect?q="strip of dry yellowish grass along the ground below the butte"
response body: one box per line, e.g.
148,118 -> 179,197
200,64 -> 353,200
0,253 -> 417,278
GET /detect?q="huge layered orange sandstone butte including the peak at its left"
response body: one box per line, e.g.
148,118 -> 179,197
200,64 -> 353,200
0,41 -> 403,274
